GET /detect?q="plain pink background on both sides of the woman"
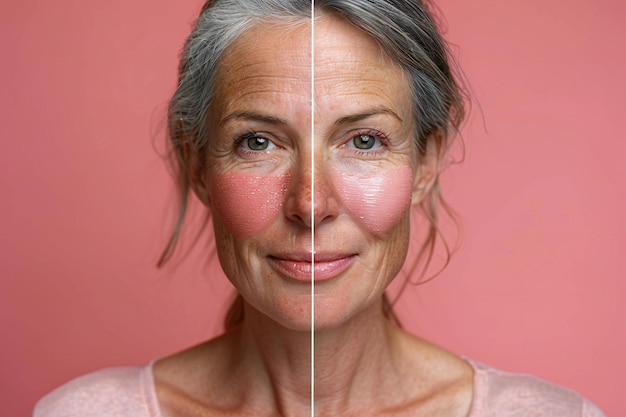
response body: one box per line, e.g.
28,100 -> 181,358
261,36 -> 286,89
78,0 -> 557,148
0,0 -> 626,416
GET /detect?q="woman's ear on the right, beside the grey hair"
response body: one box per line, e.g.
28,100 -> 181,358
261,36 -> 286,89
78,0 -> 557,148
411,130 -> 445,205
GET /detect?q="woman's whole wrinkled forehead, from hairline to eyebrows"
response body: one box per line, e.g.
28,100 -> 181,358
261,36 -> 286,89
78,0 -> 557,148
216,16 -> 409,125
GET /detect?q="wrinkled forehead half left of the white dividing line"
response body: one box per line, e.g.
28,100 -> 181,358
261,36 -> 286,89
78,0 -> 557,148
212,25 -> 312,137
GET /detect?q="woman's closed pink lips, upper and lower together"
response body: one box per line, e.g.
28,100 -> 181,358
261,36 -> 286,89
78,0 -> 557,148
268,252 -> 356,282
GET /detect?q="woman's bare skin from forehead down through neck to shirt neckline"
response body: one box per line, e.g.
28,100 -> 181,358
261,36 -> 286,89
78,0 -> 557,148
154,16 -> 472,417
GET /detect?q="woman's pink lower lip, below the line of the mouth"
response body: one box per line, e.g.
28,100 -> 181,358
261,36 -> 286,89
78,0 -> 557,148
269,256 -> 354,282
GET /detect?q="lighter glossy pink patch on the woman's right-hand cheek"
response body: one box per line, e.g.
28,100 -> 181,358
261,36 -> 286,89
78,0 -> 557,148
331,166 -> 413,234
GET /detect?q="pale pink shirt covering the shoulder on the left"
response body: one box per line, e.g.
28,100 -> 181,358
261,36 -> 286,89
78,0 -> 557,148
33,366 -> 153,417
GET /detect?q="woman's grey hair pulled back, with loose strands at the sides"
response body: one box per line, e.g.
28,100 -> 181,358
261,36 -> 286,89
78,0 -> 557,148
159,0 -> 466,324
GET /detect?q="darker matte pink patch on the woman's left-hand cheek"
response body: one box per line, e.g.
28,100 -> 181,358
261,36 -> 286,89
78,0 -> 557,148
211,174 -> 289,237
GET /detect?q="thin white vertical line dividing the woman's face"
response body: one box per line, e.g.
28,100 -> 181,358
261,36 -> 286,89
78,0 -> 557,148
311,0 -> 315,417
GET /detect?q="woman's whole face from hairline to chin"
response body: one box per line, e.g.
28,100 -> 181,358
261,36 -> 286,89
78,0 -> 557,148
202,16 -> 421,330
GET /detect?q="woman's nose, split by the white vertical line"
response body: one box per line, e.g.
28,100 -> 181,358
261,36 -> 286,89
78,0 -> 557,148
284,157 -> 339,228
